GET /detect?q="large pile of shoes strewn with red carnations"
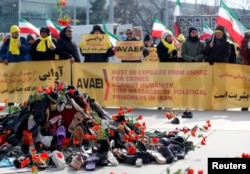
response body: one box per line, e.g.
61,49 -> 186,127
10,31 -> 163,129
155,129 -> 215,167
0,81 -> 198,170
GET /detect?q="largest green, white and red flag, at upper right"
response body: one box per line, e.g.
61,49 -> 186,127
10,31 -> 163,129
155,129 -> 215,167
216,1 -> 246,45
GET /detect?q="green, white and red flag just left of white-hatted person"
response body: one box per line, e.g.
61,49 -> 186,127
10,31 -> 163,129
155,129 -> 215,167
151,19 -> 179,45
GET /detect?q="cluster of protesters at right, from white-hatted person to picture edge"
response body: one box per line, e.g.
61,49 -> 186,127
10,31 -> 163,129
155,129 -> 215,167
152,26 -> 250,65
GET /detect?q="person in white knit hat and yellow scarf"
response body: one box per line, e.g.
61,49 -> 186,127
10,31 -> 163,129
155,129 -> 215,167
156,31 -> 177,62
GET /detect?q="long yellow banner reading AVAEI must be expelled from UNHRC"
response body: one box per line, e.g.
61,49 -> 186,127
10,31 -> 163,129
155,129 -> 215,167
73,63 -> 212,109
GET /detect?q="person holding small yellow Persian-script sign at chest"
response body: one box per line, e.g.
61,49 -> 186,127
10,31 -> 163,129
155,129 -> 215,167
80,25 -> 114,62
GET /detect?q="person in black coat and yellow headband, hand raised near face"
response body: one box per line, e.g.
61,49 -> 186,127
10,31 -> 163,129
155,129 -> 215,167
203,26 -> 230,65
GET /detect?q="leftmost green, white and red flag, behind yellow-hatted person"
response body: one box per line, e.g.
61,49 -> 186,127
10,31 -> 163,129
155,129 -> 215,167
19,18 -> 40,36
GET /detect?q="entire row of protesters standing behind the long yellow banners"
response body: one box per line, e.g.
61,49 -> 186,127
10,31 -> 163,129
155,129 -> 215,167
0,25 -> 250,65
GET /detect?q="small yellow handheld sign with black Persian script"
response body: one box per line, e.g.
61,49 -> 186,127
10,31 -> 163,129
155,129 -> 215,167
80,34 -> 110,53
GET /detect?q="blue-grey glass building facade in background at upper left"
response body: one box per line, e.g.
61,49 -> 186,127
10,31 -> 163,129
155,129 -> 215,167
0,0 -> 86,33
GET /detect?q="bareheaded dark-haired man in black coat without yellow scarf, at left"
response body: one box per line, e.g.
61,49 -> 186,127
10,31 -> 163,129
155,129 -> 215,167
56,26 -> 80,63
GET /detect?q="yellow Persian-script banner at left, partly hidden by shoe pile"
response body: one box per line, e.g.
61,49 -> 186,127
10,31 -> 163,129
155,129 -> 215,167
0,61 -> 71,102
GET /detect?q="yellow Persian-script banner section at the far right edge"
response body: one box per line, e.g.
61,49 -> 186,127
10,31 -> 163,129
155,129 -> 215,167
212,64 -> 250,110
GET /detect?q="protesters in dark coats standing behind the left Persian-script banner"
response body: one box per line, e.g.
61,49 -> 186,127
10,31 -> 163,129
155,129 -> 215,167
0,25 -> 80,65
